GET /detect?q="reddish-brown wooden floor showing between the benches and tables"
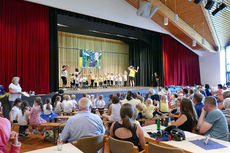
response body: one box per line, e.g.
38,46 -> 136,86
7,121 -> 153,153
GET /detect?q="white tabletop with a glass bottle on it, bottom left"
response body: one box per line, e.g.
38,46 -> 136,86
24,143 -> 83,153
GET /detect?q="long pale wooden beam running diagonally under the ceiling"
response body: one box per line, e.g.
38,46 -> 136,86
148,0 -> 216,52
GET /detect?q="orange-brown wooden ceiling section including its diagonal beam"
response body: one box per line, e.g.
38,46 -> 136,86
126,0 -> 218,51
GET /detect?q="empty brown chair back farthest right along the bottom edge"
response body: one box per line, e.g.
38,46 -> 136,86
147,142 -> 184,153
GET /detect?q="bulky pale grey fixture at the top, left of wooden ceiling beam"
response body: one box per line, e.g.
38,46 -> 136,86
136,0 -> 158,18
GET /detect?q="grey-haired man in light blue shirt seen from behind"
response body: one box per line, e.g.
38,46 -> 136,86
61,98 -> 105,142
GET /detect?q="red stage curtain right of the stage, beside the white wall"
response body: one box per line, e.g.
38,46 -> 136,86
162,35 -> 200,86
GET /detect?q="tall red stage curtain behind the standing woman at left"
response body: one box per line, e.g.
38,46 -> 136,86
0,0 -> 49,93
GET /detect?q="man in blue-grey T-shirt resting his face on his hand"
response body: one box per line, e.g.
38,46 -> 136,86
197,96 -> 229,141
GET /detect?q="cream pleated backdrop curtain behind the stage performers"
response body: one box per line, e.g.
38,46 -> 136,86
58,31 -> 129,86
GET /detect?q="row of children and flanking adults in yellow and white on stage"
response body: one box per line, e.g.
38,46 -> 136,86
61,65 -> 139,90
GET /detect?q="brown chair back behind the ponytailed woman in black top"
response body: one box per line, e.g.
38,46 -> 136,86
109,137 -> 138,153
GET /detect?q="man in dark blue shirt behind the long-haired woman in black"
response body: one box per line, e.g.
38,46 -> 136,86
192,93 -> 204,118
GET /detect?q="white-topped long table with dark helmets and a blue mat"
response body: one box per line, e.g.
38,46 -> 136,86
143,124 -> 230,153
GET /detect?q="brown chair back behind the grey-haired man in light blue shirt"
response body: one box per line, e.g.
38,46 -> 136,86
76,134 -> 104,153
